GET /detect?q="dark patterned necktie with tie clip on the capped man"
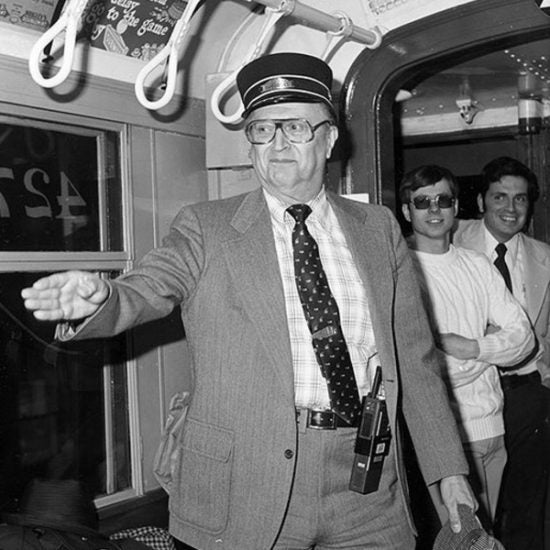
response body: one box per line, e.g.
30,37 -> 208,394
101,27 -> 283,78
287,204 -> 360,424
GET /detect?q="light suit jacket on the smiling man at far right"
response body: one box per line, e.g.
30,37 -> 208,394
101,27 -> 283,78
453,220 -> 550,386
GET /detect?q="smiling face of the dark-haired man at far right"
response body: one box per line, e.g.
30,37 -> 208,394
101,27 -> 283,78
477,176 -> 529,243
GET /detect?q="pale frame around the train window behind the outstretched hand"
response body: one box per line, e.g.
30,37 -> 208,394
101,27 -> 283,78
0,101 -> 144,508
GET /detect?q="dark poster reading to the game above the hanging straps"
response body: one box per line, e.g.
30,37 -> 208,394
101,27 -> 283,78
84,0 -> 187,61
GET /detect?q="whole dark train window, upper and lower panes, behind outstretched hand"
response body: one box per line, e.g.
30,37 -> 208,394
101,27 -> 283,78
0,115 -> 132,512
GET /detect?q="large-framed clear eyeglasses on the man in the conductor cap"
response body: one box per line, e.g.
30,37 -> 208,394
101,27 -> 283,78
245,118 -> 333,145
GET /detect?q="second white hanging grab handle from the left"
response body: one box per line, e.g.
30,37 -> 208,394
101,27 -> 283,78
134,0 -> 201,111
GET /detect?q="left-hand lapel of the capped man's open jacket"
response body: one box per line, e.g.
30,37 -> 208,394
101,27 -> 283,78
225,194 -> 294,398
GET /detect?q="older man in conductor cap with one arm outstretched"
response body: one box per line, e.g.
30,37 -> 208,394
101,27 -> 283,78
22,53 -> 476,550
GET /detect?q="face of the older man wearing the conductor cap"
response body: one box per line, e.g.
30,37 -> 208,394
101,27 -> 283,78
246,103 -> 338,202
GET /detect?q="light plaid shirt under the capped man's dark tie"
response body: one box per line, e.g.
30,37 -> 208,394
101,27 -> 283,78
264,189 -> 379,409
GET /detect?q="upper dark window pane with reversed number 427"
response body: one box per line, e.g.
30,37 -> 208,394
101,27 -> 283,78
0,117 -> 122,252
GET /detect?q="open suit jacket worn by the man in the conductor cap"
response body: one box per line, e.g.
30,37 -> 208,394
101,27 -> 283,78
64,190 -> 467,550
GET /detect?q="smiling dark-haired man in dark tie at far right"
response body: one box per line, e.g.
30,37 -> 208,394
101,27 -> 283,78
454,157 -> 550,550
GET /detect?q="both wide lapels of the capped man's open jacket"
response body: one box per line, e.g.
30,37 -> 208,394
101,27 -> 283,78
225,190 -> 402,404
